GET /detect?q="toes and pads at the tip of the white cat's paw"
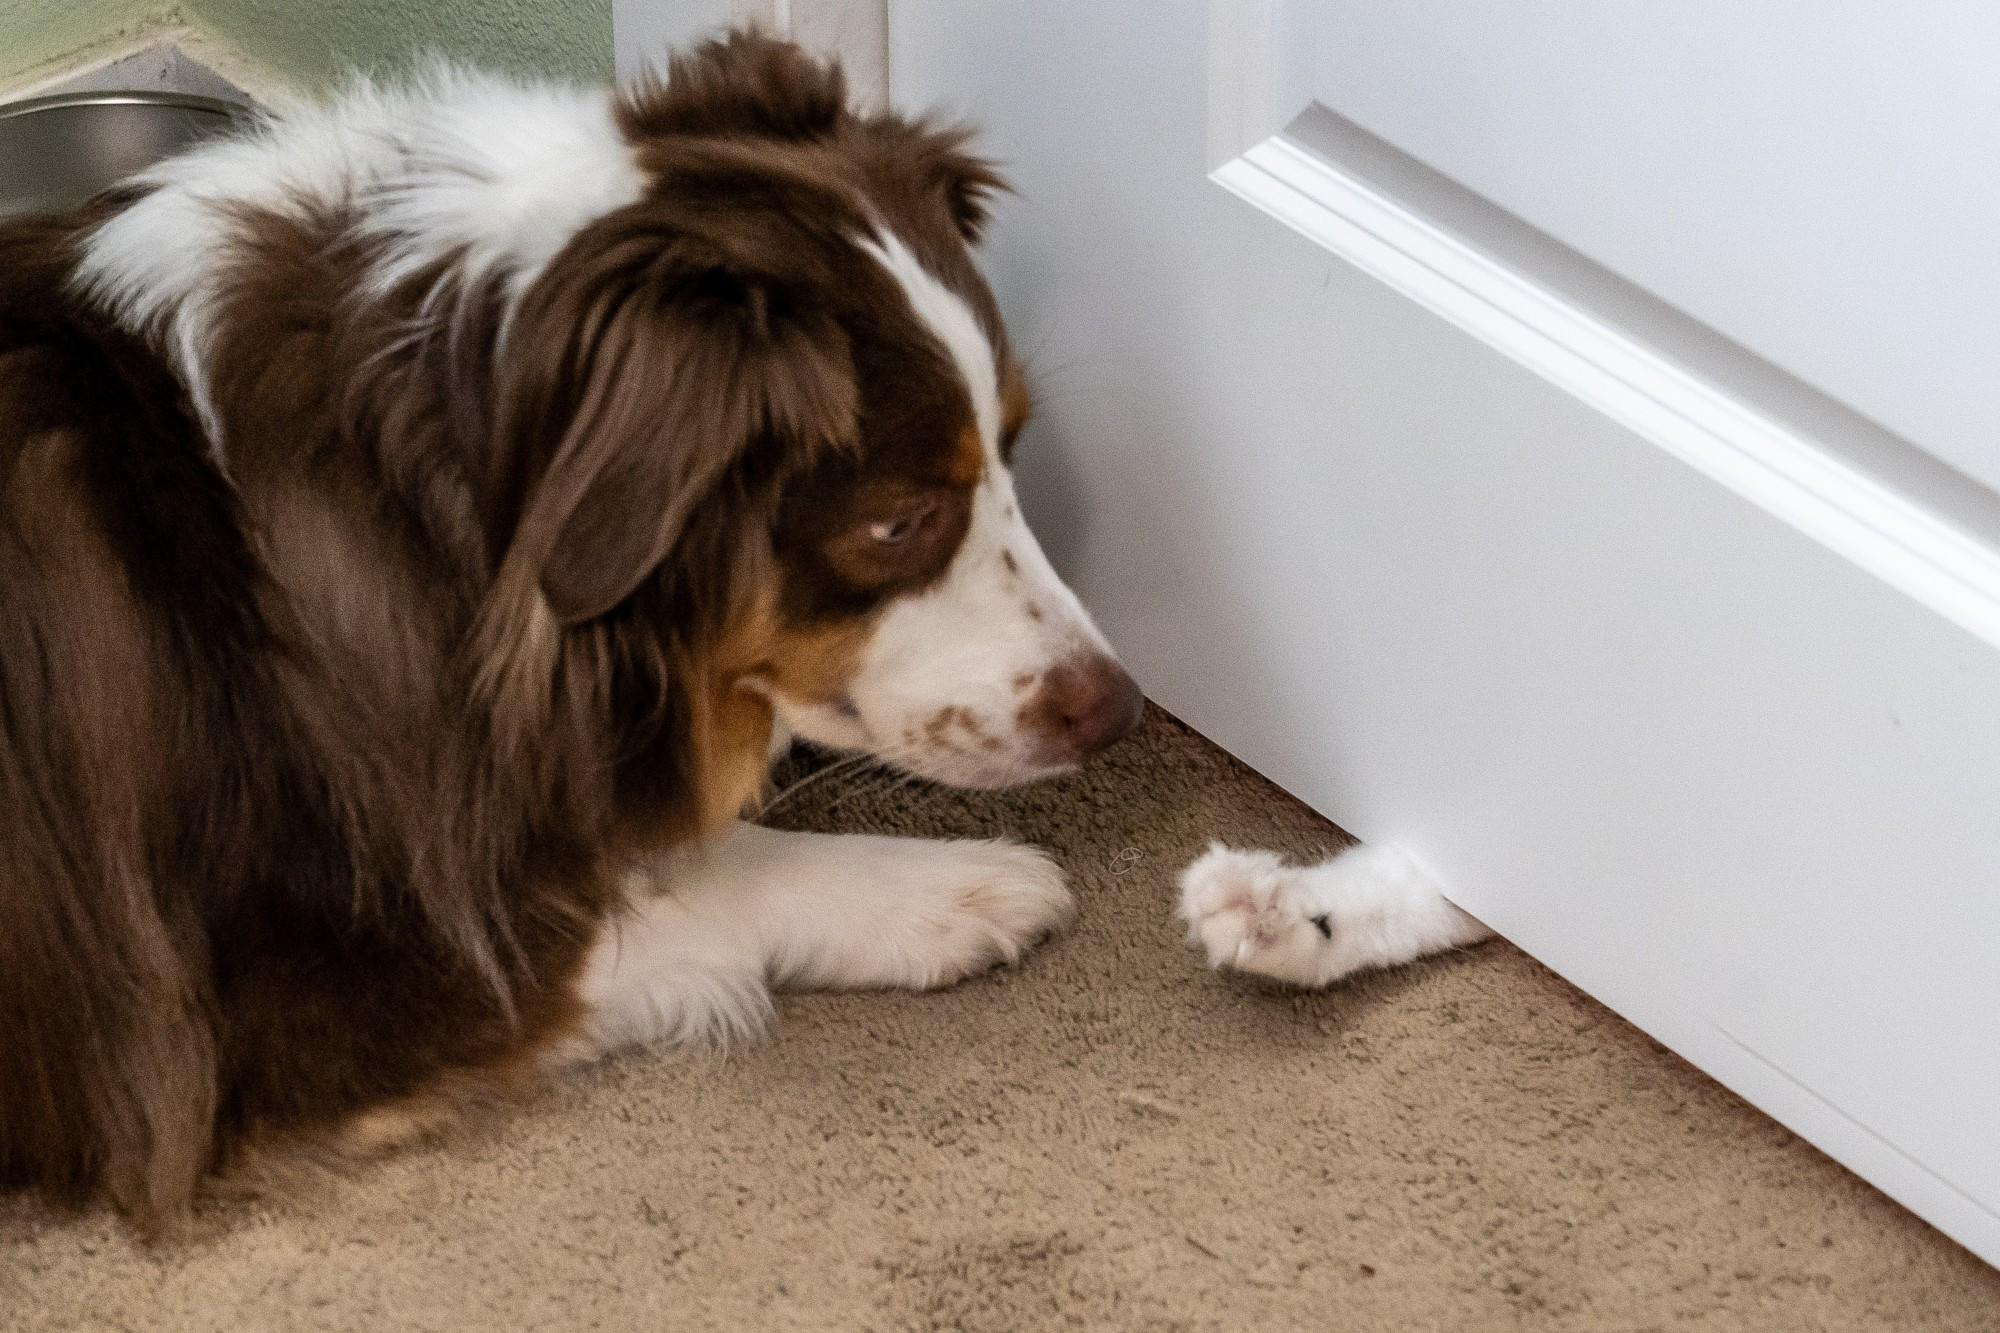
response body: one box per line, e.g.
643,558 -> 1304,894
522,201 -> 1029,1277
1180,843 -> 1332,981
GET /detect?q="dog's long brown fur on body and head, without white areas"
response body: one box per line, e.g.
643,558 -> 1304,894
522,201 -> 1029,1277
0,38 -> 1020,1219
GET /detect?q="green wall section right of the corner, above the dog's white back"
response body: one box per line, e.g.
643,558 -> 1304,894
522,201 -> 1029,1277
189,0 -> 612,88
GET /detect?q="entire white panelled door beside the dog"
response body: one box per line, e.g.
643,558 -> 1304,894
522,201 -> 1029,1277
630,0 -> 2000,1261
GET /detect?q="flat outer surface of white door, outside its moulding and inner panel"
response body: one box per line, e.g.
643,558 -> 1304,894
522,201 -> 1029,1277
890,0 -> 2000,1261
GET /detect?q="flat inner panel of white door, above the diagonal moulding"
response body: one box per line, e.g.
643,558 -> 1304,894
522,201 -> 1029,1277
1304,0 -> 2000,484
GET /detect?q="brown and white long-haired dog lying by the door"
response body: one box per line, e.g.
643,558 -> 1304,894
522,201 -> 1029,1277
0,36 -> 1140,1219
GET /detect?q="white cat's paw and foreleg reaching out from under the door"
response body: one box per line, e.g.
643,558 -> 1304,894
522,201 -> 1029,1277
1180,843 -> 1492,987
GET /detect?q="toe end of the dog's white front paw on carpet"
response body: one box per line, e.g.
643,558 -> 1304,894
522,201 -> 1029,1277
898,843 -> 1076,989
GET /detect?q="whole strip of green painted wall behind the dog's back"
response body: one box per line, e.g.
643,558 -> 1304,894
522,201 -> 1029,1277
0,0 -> 612,88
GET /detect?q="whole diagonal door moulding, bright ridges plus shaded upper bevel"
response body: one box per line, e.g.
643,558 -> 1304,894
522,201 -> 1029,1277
1212,106 -> 2000,646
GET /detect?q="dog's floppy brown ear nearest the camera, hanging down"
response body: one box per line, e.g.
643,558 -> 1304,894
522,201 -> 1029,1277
504,220 -> 856,624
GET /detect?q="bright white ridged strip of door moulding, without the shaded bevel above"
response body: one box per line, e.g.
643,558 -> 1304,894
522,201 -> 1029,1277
1212,131 -> 2000,646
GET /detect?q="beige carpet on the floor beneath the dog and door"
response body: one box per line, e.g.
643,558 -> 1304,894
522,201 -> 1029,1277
0,700 -> 2000,1333
